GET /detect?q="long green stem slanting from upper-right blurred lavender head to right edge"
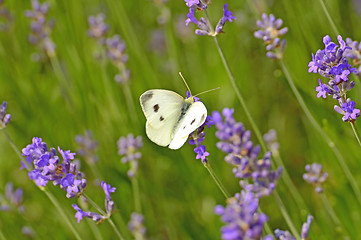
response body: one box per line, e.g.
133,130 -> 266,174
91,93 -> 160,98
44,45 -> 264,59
280,59 -> 361,205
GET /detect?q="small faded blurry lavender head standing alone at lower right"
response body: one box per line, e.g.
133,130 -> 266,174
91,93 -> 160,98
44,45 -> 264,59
303,163 -> 328,193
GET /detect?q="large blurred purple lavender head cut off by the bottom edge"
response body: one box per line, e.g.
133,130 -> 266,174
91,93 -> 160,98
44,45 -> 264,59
214,191 -> 268,240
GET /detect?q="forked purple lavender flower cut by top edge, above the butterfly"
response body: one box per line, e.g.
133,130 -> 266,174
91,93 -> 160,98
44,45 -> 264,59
185,0 -> 236,36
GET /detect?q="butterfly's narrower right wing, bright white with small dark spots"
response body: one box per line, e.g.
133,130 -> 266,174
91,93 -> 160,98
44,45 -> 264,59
168,102 -> 207,149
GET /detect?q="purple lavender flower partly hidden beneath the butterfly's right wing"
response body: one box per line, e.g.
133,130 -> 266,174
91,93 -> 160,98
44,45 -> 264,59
189,114 -> 214,164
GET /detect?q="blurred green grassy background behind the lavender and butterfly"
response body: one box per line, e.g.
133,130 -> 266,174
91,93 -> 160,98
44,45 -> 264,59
0,0 -> 361,239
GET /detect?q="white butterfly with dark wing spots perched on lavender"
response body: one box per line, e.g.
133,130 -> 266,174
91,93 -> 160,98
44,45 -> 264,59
140,89 -> 207,149
